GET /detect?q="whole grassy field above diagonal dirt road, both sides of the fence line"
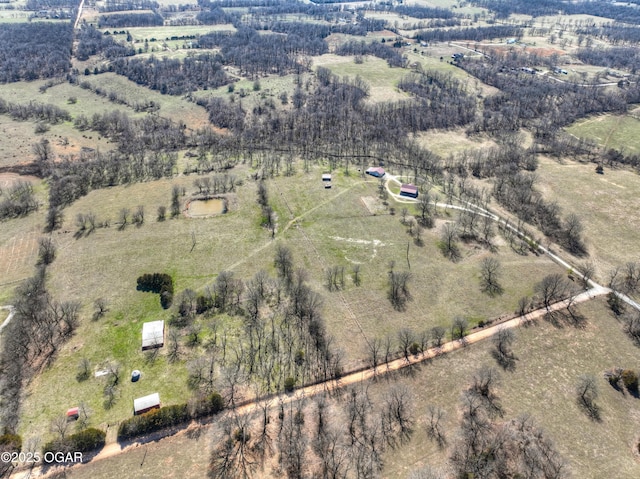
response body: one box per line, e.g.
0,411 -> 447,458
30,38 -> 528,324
7,162 -> 562,446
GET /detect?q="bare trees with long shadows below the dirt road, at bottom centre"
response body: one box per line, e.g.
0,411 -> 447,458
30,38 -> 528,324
209,386 -> 415,479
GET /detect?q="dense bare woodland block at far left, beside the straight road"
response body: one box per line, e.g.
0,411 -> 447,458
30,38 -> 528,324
0,22 -> 73,83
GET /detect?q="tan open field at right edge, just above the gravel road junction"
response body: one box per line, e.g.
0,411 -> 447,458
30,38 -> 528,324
537,157 -> 640,282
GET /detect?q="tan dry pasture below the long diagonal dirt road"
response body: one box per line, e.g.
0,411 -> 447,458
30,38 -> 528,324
62,300 -> 640,479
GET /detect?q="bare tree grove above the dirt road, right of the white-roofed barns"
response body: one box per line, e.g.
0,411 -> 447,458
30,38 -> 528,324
169,244 -> 342,405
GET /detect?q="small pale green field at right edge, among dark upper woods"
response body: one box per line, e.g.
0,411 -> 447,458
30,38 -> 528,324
566,114 -> 640,155
